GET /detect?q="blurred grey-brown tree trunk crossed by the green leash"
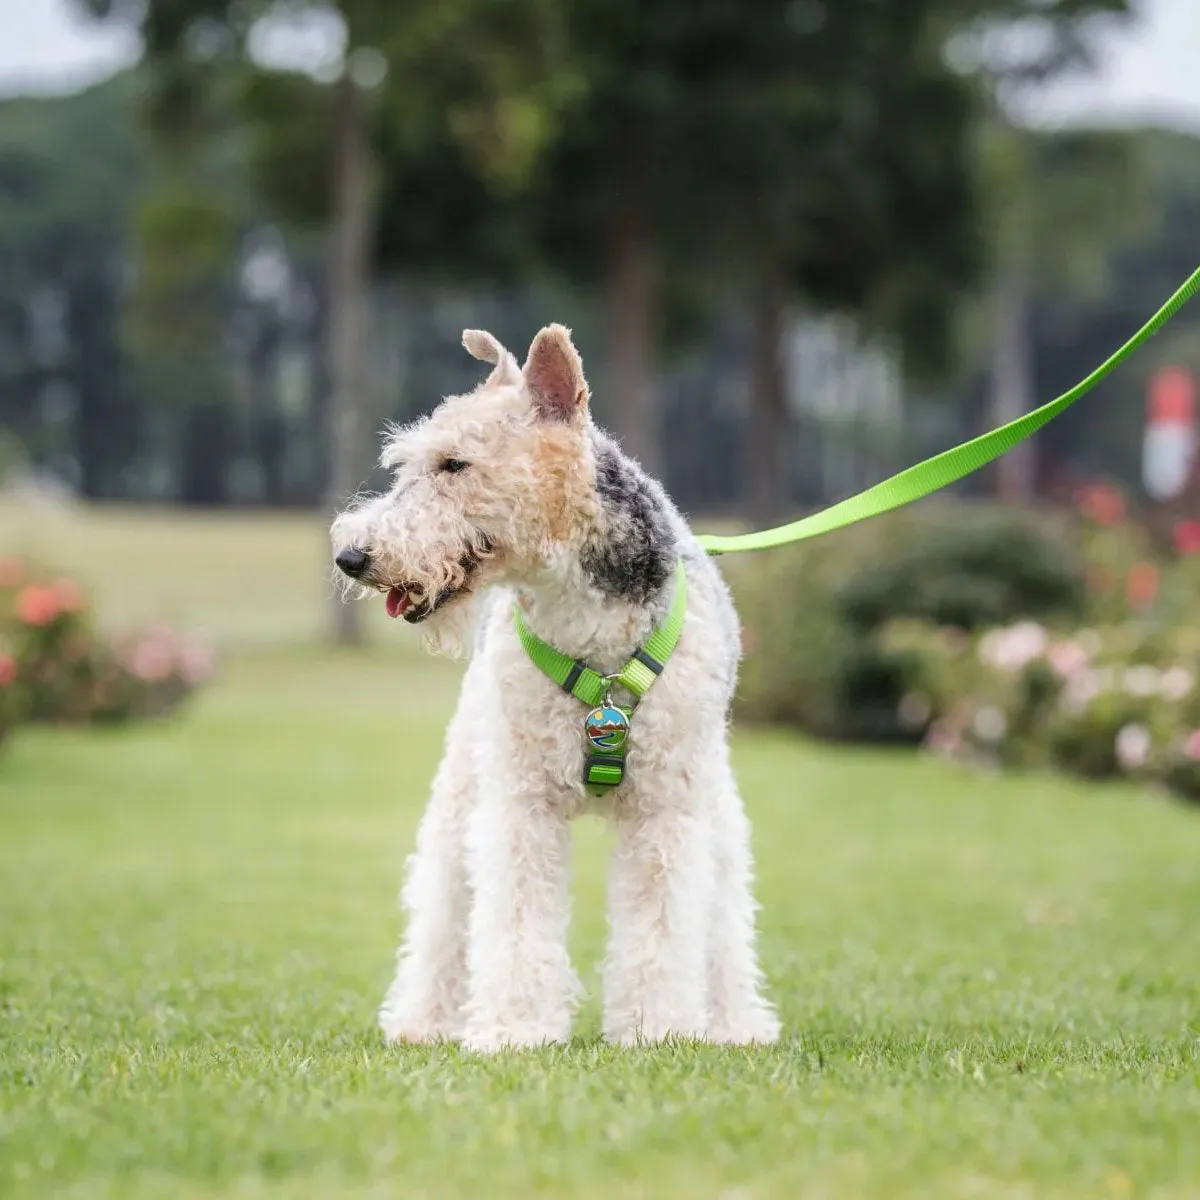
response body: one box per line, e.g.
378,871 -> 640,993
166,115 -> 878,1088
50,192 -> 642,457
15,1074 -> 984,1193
989,271 -> 1036,504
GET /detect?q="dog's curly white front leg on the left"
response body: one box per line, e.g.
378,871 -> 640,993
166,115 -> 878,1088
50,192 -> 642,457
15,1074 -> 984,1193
463,772 -> 580,1050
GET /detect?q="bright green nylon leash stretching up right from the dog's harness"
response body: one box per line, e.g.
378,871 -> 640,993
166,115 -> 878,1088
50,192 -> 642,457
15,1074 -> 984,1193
696,268 -> 1200,554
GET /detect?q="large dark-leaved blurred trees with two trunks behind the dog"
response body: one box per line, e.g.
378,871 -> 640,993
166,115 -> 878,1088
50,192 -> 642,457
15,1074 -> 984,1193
523,0 -> 1127,520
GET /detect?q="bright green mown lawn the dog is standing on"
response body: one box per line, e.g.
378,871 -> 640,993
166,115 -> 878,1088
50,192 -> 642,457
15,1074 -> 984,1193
0,501 -> 1200,1200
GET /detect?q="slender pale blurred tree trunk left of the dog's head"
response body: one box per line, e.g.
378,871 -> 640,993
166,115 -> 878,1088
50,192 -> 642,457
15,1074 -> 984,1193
328,70 -> 373,643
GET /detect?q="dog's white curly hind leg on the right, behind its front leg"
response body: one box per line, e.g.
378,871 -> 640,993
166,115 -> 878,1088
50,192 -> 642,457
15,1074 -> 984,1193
707,755 -> 779,1044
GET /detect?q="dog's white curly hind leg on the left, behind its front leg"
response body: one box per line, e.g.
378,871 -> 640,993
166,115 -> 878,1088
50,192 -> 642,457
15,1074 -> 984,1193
379,670 -> 478,1042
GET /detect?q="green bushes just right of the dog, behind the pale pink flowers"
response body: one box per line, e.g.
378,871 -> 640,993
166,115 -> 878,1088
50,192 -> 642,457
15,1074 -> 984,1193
733,505 -> 1086,740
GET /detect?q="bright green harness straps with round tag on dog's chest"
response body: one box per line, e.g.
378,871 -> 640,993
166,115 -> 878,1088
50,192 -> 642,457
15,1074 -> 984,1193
512,562 -> 688,791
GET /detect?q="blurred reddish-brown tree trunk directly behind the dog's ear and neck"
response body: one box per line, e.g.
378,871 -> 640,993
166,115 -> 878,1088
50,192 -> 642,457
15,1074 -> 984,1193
608,202 -> 659,474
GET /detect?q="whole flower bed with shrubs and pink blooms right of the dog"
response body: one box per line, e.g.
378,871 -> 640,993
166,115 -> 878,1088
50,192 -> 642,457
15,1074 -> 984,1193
731,485 -> 1200,798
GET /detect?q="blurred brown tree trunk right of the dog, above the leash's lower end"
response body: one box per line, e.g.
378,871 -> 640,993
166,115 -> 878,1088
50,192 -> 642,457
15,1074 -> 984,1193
746,268 -> 791,524
